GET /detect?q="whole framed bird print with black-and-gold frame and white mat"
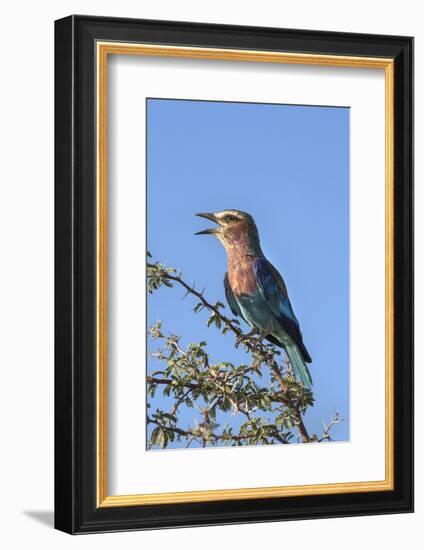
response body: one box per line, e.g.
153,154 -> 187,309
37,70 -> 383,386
55,16 -> 413,533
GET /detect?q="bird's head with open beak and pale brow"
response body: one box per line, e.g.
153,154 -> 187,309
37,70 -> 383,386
196,210 -> 260,254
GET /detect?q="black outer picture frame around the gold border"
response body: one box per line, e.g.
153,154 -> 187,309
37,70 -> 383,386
55,15 -> 413,534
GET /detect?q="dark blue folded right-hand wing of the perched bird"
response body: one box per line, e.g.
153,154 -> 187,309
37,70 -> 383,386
253,258 -> 312,363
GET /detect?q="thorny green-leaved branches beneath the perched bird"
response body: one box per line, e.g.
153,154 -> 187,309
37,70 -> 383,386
147,255 -> 340,448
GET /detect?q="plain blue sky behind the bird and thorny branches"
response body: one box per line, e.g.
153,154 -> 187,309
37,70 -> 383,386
147,99 -> 349,448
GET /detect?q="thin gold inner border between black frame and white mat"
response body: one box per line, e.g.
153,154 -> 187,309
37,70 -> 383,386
96,41 -> 394,508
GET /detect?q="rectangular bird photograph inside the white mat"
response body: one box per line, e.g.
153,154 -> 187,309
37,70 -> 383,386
147,97 -> 350,452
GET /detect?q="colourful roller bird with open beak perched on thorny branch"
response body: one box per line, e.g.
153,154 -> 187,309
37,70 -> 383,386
196,210 -> 312,388
